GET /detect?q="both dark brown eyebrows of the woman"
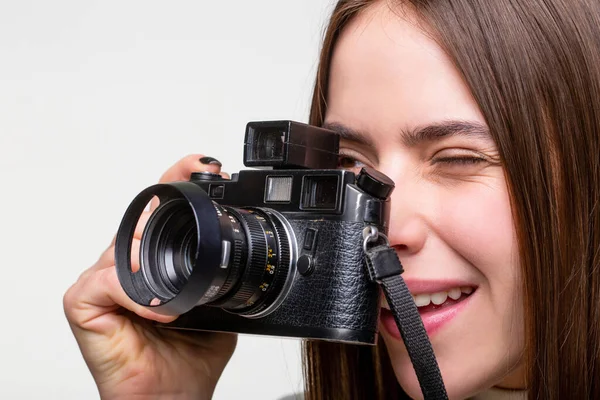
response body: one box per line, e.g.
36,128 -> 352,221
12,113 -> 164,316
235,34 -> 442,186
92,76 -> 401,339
323,120 -> 491,148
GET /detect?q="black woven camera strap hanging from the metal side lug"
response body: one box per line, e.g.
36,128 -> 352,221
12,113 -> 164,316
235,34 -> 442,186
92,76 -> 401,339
363,226 -> 448,400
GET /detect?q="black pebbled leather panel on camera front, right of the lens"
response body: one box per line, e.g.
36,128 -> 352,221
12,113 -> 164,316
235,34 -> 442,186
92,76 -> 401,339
270,220 -> 378,329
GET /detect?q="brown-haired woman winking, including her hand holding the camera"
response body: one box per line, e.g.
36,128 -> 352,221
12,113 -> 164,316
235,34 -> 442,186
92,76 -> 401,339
65,0 -> 600,399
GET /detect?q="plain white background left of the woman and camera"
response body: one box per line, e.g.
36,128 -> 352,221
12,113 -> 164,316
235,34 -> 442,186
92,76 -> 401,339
0,0 -> 332,399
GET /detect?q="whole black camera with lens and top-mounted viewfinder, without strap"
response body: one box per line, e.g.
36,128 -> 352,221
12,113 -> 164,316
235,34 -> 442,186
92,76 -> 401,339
116,121 -> 394,344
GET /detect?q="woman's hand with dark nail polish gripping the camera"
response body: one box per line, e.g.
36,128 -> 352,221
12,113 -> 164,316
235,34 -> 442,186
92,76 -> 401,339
64,155 -> 236,399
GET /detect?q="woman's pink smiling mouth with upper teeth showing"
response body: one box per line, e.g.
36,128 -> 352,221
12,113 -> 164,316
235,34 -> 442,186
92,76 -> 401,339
381,281 -> 477,339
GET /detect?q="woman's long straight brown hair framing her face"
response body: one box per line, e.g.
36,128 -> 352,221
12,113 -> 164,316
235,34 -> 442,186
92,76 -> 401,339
304,0 -> 600,400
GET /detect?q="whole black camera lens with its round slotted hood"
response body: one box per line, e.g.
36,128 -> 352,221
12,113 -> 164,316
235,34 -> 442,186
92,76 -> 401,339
116,183 -> 292,317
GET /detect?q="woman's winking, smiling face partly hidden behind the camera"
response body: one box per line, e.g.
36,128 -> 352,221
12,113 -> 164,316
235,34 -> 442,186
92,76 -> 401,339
325,5 -> 524,398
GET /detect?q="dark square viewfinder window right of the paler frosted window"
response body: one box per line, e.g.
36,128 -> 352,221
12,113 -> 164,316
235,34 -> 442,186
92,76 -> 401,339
301,175 -> 338,210
